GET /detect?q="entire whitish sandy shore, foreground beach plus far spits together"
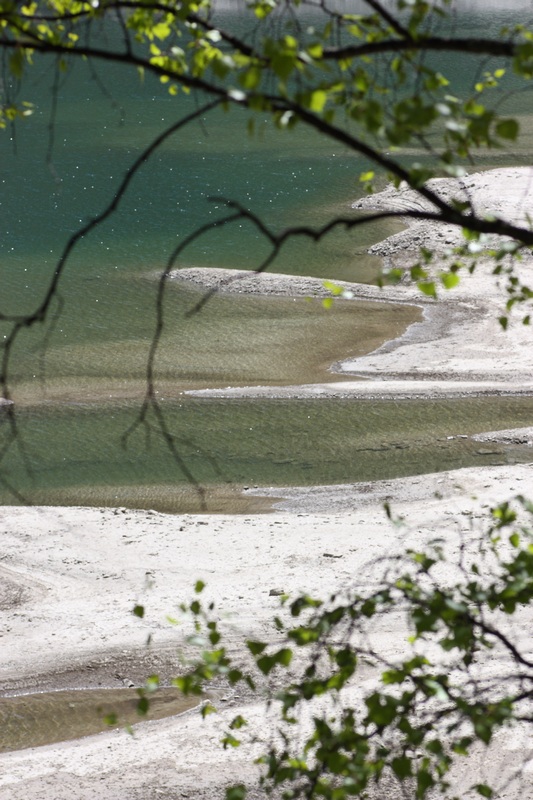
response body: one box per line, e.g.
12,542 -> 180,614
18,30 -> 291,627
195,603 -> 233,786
0,170 -> 533,800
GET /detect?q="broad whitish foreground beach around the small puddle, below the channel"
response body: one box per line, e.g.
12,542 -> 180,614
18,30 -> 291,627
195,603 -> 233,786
0,464 -> 533,800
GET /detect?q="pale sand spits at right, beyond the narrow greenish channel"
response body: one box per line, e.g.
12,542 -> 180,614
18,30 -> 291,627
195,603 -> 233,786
178,168 -> 533,398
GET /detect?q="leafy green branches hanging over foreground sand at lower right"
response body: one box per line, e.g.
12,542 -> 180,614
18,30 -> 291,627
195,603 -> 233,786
170,497 -> 533,800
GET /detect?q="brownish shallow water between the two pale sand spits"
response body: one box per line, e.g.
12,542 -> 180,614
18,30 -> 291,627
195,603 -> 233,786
6,286 -> 421,405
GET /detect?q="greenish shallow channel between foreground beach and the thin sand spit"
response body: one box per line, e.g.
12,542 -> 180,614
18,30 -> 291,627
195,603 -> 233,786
4,397 -> 533,512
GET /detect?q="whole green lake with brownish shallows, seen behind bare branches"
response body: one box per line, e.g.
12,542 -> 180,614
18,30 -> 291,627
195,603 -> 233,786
0,4 -> 533,511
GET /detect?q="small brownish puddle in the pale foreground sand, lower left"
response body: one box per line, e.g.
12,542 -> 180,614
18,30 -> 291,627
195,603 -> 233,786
0,688 -> 198,753
